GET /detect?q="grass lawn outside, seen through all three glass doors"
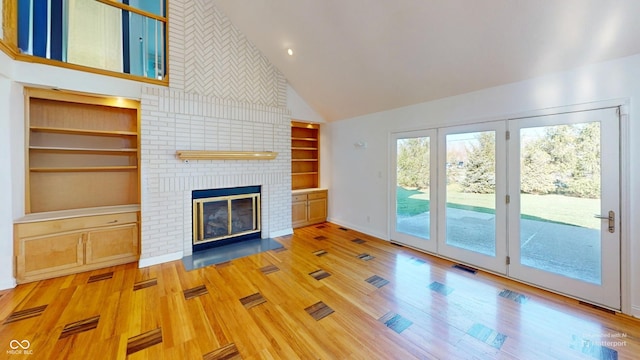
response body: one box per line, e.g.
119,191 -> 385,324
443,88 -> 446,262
396,187 -> 601,229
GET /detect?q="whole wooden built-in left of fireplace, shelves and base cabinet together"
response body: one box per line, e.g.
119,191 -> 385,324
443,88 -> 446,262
14,89 -> 140,282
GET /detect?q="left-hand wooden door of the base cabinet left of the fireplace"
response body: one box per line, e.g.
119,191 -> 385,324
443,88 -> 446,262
16,232 -> 84,282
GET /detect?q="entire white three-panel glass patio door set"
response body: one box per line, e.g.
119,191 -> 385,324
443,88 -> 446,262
391,108 -> 620,309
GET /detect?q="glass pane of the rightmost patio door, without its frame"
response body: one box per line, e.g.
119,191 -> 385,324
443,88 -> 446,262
520,122 -> 602,284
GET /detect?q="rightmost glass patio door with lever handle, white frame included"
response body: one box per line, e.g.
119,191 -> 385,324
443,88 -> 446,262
509,109 -> 620,309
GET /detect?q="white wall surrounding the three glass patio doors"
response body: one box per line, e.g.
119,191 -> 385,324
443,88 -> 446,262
325,55 -> 640,316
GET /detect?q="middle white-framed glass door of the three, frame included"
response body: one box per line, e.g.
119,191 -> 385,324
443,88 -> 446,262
439,122 -> 506,273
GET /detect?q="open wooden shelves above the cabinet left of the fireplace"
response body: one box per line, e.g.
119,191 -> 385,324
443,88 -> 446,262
26,89 -> 140,213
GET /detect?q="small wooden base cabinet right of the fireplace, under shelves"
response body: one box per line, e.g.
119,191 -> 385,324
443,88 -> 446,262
291,189 -> 327,228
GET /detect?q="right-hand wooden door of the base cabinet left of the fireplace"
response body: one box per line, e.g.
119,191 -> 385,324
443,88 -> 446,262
85,223 -> 139,265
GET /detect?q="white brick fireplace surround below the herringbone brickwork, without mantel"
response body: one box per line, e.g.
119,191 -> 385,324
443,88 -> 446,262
140,87 -> 292,267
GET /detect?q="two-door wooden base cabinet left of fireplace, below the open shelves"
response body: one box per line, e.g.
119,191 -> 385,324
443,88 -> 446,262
14,210 -> 139,283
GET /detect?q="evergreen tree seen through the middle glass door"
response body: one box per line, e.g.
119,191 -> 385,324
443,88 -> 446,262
461,131 -> 496,194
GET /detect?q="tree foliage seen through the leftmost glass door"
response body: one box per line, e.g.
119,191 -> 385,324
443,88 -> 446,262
397,137 -> 430,189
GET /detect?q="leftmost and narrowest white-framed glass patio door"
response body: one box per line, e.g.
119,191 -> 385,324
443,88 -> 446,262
391,131 -> 436,251
